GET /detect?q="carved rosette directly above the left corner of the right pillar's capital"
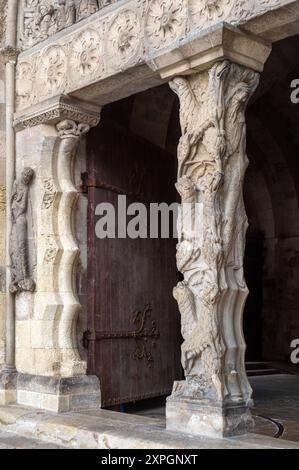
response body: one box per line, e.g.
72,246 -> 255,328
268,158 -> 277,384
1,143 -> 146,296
145,0 -> 188,48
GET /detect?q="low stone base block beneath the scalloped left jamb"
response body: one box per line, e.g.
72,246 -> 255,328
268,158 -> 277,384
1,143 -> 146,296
17,374 -> 101,413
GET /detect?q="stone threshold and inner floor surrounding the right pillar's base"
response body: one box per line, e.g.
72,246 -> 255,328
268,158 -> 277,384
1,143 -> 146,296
0,374 -> 299,449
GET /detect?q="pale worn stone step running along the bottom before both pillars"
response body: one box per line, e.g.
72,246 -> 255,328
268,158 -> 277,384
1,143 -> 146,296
0,406 -> 299,449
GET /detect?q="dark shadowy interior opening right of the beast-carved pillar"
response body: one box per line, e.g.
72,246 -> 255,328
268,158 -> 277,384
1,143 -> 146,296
244,36 -> 299,365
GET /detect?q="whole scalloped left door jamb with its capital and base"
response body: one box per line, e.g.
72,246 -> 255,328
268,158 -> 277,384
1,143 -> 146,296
15,96 -> 100,412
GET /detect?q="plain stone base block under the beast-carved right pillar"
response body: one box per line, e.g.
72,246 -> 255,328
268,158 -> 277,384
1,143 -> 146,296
166,397 -> 254,438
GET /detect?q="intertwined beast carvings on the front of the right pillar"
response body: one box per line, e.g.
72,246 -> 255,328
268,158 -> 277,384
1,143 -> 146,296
170,61 -> 258,401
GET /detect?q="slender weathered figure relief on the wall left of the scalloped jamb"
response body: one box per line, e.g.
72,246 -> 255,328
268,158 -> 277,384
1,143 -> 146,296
9,168 -> 35,294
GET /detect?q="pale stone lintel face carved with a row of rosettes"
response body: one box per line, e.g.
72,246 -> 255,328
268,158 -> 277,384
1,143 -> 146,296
17,0 -> 299,110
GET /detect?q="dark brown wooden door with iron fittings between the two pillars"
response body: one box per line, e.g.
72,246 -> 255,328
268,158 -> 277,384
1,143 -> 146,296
88,123 -> 181,406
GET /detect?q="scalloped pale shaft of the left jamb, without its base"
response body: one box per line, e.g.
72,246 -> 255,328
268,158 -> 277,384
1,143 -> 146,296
16,119 -> 90,377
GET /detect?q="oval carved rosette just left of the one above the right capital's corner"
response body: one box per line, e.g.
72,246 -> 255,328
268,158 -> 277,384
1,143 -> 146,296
107,10 -> 142,67
